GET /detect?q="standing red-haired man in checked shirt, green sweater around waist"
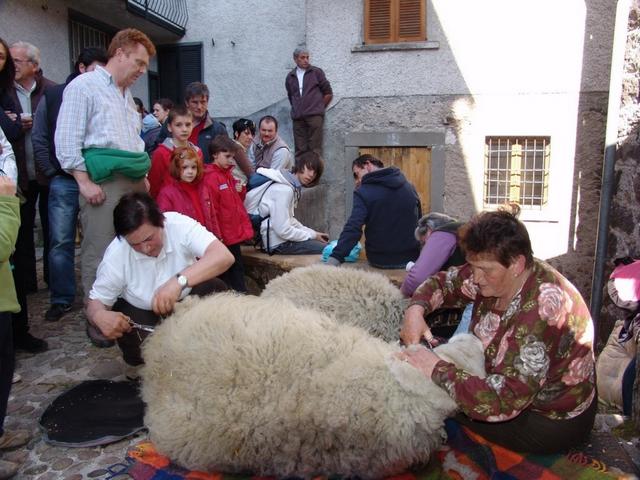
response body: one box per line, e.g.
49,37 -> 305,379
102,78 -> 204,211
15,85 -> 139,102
55,28 -> 156,347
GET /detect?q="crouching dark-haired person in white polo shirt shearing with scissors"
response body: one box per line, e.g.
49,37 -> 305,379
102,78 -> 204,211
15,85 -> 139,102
87,192 -> 234,366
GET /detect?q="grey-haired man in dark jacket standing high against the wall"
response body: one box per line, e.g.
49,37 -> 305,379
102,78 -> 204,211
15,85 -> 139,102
284,48 -> 333,158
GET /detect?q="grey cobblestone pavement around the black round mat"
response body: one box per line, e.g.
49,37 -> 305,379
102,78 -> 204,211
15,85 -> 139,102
6,253 -> 640,480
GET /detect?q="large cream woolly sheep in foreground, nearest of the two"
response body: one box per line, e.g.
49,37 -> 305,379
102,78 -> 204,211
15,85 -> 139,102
141,293 -> 484,479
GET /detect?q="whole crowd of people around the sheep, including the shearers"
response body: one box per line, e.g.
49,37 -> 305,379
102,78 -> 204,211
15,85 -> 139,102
0,29 -> 595,478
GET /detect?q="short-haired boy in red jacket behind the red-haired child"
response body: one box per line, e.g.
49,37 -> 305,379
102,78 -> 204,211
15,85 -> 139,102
147,105 -> 203,200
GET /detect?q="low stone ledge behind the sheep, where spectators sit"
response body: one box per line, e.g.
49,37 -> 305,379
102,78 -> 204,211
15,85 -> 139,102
242,246 -> 407,294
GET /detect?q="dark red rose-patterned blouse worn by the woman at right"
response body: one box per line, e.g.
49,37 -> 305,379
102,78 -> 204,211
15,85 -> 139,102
415,260 -> 595,422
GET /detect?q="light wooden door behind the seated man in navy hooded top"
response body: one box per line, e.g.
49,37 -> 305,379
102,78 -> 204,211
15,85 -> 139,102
360,147 -> 431,215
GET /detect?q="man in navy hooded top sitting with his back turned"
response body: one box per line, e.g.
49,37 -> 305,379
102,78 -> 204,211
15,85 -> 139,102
327,154 -> 422,268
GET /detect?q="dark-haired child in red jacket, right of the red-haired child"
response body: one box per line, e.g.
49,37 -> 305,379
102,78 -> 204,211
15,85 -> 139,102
205,135 -> 253,292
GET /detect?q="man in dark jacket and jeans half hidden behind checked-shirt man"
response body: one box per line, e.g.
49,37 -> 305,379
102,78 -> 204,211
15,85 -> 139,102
31,47 -> 108,322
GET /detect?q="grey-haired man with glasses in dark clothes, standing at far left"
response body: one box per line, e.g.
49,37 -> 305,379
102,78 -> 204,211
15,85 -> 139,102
8,42 -> 55,353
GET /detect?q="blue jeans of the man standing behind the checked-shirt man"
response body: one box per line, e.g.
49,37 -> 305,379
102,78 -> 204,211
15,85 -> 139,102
49,175 -> 79,305
